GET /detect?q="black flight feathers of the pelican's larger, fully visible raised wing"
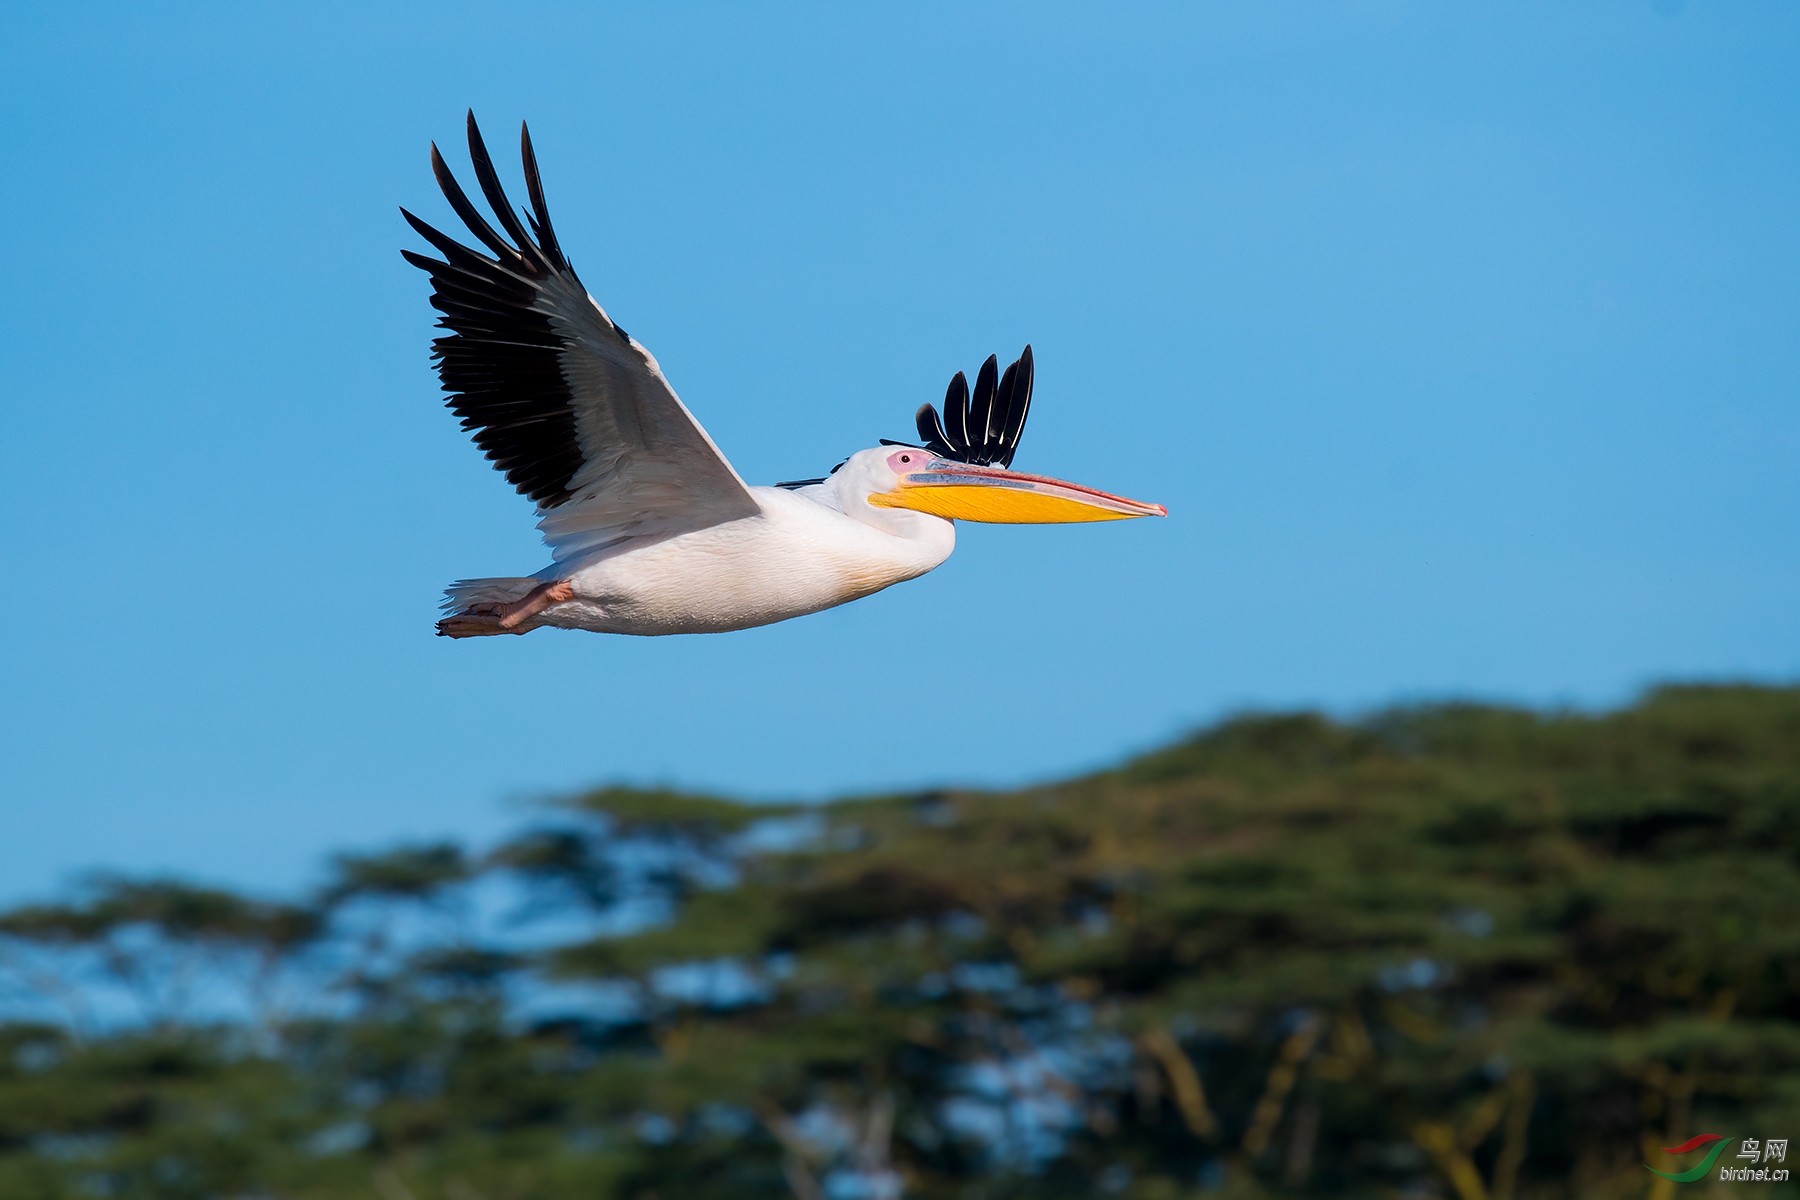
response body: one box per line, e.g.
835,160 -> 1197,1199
401,112 -> 586,509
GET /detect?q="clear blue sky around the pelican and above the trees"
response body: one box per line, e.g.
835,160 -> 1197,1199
0,0 -> 1800,900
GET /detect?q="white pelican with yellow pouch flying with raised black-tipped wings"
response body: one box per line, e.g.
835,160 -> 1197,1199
401,112 -> 1166,637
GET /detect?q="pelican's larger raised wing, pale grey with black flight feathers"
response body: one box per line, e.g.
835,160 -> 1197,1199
400,112 -> 761,561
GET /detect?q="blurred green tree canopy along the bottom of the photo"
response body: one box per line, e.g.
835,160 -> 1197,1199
0,687 -> 1800,1200
